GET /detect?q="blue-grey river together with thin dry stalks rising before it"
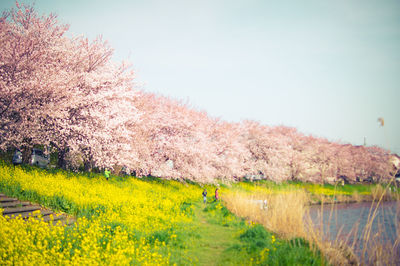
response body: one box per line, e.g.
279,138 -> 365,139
309,201 -> 400,265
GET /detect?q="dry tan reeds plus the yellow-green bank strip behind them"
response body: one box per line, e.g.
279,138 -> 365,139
223,181 -> 400,265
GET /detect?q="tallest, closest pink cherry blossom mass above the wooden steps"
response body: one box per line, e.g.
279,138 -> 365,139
0,3 -> 138,166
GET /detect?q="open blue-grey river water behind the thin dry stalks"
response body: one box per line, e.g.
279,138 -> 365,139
310,201 -> 400,263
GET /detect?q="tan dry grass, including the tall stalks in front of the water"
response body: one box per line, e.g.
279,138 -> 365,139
223,186 -> 400,265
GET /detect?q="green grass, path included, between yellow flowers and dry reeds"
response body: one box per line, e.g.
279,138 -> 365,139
166,202 -> 325,265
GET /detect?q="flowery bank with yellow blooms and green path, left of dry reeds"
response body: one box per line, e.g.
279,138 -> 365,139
0,164 -> 325,265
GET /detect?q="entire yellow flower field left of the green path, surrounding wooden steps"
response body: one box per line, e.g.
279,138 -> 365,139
0,165 -> 201,265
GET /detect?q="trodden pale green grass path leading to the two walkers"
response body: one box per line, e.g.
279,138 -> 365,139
187,202 -> 244,265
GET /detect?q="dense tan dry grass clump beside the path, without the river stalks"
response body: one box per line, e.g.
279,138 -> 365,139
223,190 -> 355,265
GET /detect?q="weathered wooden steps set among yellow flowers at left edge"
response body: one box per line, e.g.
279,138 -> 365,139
0,193 -> 75,225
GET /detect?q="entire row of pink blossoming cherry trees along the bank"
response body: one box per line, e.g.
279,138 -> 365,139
0,3 -> 392,182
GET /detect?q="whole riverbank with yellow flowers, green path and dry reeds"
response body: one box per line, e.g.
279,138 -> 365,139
0,161 -> 398,265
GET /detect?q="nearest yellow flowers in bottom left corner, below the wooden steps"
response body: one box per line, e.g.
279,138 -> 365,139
0,216 -> 168,265
